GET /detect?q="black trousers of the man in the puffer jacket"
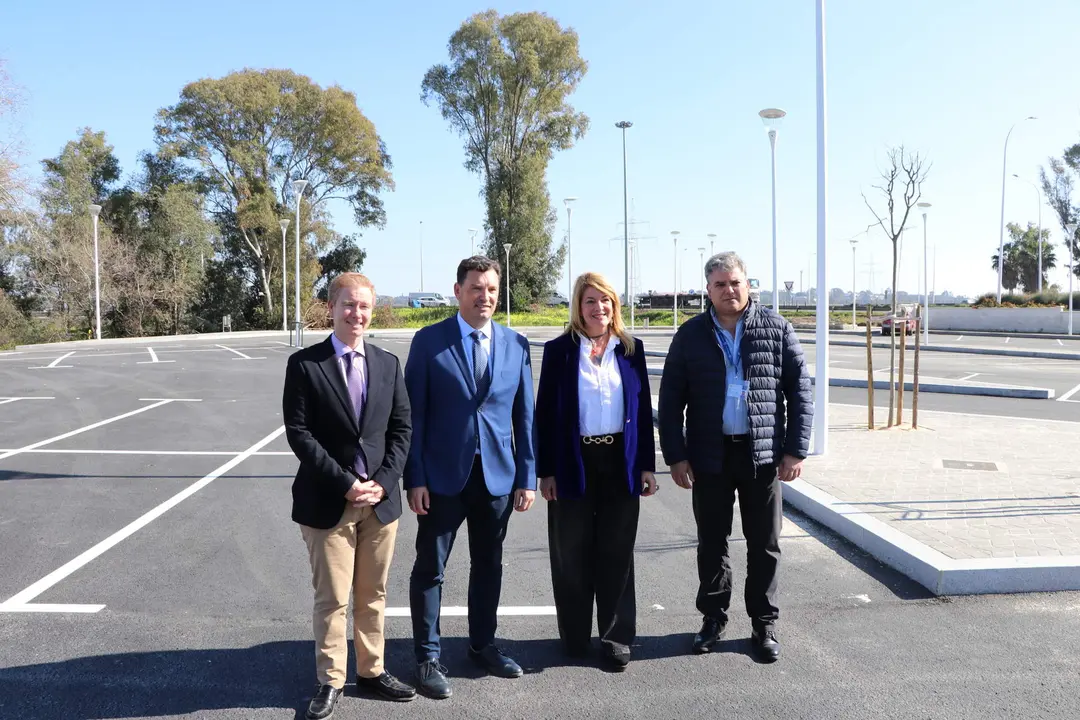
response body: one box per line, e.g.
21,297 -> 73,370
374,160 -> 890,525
693,437 -> 783,628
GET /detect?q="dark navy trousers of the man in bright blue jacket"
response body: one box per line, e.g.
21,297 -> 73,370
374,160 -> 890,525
409,456 -> 514,663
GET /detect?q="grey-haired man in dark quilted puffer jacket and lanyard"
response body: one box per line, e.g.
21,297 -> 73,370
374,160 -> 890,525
658,253 -> 813,662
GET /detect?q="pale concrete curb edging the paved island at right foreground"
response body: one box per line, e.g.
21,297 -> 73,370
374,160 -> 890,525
783,479 -> 1080,595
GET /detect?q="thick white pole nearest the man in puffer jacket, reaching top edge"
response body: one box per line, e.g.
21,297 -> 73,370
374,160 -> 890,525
812,0 -> 828,456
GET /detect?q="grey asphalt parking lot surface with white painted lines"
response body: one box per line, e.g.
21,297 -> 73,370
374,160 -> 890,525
0,334 -> 1080,720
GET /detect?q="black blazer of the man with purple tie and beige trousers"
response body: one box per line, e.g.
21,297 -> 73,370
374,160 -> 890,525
282,338 -> 413,530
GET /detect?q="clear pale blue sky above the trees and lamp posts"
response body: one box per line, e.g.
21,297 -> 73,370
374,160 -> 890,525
0,0 -> 1080,294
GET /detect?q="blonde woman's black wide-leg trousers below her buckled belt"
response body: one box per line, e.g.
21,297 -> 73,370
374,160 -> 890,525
548,435 -> 640,653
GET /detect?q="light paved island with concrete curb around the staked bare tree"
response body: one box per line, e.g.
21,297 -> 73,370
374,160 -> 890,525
785,405 -> 1080,593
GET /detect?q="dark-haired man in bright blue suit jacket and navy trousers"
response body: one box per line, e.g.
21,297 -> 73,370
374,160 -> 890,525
404,257 -> 536,698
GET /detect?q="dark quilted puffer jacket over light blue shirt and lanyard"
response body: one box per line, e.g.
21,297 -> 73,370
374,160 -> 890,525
657,301 -> 813,473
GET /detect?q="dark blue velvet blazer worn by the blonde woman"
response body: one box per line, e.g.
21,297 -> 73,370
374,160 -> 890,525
535,334 -> 657,498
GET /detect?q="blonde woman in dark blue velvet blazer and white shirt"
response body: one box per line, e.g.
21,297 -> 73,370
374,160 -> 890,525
534,273 -> 657,670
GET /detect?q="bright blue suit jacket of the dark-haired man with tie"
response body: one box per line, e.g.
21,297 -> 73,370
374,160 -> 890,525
403,315 -> 537,497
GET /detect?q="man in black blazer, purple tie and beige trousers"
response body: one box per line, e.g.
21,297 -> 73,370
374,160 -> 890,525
283,273 -> 416,720
